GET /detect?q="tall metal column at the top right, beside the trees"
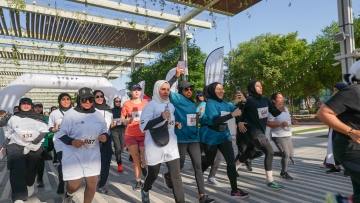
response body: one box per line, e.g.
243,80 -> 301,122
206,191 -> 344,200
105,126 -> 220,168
337,0 -> 355,74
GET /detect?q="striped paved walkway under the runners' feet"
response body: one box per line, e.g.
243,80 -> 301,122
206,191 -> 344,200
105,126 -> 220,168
0,125 -> 352,203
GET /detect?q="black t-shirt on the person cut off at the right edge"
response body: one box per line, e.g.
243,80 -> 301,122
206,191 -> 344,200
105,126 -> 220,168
325,85 -> 360,162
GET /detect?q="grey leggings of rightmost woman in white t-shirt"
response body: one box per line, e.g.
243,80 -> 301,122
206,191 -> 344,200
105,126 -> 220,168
271,136 -> 294,172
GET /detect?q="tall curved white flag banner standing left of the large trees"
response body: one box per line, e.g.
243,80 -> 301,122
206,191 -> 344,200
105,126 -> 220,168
205,47 -> 224,85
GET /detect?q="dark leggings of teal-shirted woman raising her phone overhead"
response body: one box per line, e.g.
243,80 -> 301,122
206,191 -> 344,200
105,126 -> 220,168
166,142 -> 205,194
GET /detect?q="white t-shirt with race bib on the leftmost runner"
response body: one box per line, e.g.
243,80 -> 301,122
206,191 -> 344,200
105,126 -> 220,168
5,115 -> 49,148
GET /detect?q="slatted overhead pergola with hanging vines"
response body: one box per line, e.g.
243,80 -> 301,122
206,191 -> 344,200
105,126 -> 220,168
0,0 -> 261,108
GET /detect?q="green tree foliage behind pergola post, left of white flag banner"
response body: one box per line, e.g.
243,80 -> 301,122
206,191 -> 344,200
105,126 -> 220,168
127,41 -> 206,97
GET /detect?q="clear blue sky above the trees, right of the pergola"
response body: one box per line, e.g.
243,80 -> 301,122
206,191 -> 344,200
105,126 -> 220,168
112,0 -> 360,90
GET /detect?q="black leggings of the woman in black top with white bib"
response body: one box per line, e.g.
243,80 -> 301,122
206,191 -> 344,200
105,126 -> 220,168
239,135 -> 274,171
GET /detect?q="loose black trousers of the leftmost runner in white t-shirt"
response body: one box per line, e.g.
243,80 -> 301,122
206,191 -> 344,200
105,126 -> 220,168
6,144 -> 43,202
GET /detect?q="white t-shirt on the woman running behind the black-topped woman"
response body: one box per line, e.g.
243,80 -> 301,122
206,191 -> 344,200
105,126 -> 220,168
268,107 -> 292,137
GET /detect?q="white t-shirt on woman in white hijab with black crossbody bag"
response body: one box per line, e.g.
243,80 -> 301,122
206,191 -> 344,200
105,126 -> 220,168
140,100 -> 179,166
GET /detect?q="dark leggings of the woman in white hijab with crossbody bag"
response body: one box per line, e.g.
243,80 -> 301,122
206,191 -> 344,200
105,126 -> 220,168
143,159 -> 185,203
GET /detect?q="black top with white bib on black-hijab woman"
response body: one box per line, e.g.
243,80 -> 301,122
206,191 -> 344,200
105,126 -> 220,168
241,96 -> 281,134
